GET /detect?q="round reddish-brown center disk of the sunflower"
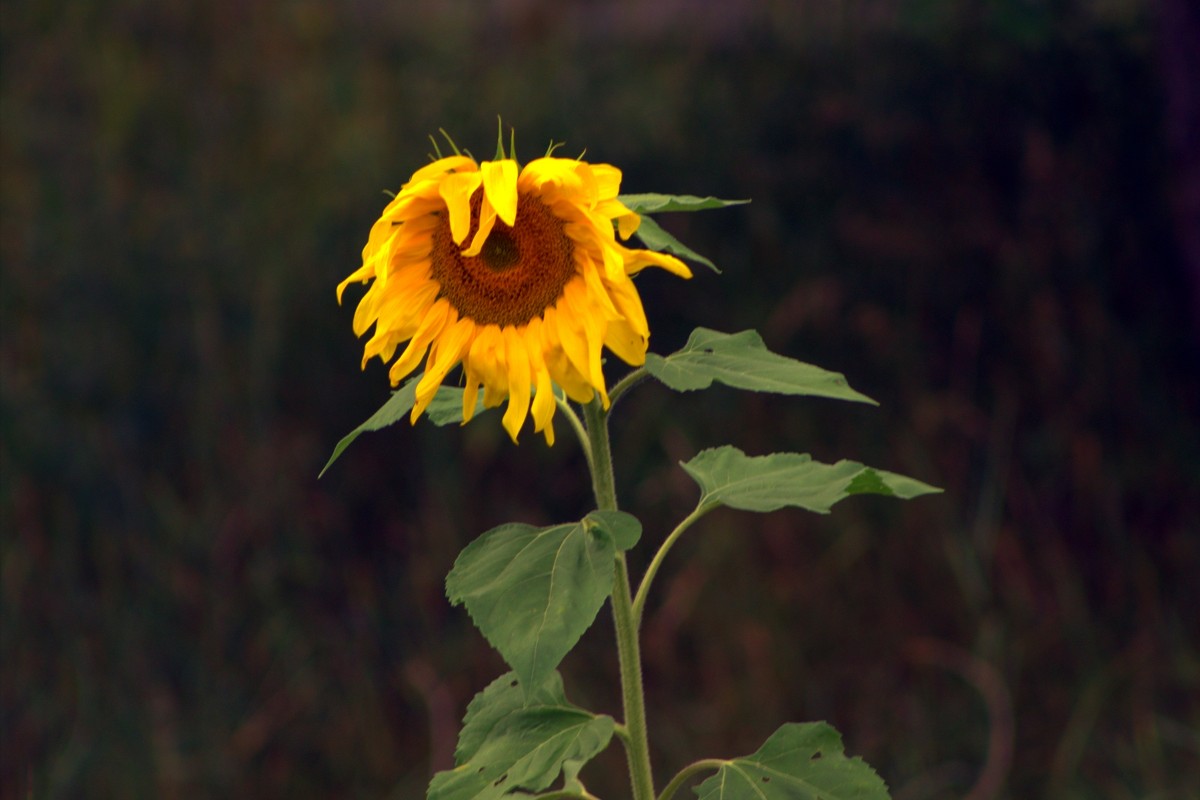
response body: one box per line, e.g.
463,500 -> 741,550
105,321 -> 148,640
430,192 -> 575,326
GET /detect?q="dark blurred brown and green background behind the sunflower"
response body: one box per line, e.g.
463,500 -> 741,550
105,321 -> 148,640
0,0 -> 1200,800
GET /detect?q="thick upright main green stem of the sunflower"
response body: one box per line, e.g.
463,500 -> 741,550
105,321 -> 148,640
583,398 -> 654,800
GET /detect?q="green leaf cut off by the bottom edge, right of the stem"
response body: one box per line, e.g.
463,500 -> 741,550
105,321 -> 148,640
695,722 -> 889,800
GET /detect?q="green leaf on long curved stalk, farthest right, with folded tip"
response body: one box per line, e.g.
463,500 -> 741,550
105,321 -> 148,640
683,445 -> 941,513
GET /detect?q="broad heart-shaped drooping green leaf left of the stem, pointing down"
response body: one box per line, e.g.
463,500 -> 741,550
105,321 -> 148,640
446,511 -> 641,686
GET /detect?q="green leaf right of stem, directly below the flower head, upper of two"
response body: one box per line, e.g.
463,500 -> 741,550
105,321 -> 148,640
646,327 -> 877,404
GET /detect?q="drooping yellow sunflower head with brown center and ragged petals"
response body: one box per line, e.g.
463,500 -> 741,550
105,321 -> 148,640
337,156 -> 691,444
